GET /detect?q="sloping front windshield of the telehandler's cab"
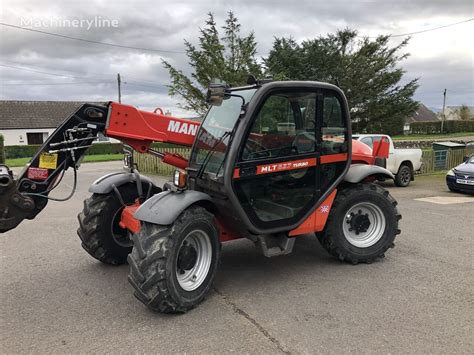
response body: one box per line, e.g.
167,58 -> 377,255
190,89 -> 257,174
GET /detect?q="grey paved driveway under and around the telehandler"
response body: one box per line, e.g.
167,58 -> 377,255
0,163 -> 474,354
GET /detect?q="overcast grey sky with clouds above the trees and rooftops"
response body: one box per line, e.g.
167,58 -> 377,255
0,0 -> 474,115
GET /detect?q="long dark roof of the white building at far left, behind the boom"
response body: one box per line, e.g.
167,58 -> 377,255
0,100 -> 104,129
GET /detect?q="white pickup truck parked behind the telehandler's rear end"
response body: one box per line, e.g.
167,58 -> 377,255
352,134 -> 422,187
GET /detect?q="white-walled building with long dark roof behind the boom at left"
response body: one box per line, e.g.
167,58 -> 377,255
0,100 -> 104,146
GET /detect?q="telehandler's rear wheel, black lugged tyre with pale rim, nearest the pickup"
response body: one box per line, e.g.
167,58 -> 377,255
317,184 -> 401,264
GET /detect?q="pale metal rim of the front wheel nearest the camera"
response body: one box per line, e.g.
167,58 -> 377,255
176,230 -> 212,291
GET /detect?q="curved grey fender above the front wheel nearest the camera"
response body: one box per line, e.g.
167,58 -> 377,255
133,190 -> 212,225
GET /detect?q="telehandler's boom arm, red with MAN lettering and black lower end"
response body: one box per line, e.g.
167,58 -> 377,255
0,102 -> 199,233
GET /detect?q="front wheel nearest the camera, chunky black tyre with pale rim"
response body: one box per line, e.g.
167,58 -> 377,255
128,206 -> 220,313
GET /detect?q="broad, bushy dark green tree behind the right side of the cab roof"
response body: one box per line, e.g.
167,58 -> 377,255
265,29 -> 418,134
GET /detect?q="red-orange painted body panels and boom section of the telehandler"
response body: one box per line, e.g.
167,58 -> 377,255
115,126 -> 389,242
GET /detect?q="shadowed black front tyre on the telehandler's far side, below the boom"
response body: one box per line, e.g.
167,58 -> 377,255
77,184 -> 138,265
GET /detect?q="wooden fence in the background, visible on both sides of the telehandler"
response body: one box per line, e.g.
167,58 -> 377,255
133,147 -> 474,176
